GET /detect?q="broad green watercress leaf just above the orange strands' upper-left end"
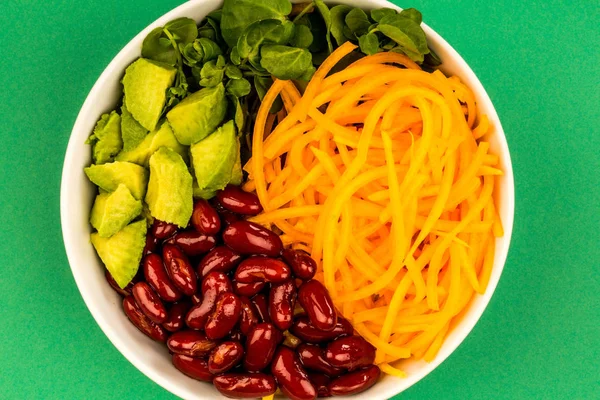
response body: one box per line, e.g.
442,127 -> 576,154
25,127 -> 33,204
260,44 -> 312,80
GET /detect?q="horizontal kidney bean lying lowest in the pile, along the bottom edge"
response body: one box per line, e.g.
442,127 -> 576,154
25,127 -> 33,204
213,373 -> 277,399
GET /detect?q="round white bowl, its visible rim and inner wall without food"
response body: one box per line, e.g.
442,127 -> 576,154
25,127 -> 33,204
60,0 -> 514,399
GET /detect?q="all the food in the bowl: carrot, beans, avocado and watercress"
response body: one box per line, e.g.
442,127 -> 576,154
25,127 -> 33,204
79,1 -> 502,398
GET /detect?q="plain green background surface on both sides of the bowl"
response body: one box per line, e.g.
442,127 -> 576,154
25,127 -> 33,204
0,0 -> 600,399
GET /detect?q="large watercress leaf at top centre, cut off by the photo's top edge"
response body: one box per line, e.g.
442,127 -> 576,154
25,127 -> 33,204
221,0 -> 292,47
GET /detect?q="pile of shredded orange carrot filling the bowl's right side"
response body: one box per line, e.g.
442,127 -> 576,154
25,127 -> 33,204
244,43 -> 503,376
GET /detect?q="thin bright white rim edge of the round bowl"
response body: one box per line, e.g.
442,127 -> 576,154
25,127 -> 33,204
60,0 -> 515,398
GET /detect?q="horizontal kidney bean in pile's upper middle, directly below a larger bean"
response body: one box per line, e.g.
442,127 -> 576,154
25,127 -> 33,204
235,257 -> 291,283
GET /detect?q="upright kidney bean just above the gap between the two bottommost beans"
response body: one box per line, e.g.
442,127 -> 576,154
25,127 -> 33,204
244,323 -> 282,372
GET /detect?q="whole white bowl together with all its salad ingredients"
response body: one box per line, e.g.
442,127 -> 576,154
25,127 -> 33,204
61,0 -> 514,399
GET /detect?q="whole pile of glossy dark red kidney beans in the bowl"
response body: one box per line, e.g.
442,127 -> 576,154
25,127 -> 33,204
107,186 -> 380,400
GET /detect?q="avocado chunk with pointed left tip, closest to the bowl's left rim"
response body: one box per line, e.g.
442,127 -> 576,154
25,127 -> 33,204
84,161 -> 148,200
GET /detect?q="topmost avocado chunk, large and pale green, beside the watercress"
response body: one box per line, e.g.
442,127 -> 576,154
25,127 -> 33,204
123,58 -> 177,131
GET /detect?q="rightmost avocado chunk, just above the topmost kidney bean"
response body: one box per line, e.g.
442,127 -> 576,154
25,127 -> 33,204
190,121 -> 239,191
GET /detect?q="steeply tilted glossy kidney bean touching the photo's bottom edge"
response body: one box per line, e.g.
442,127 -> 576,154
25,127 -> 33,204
271,346 -> 317,400
